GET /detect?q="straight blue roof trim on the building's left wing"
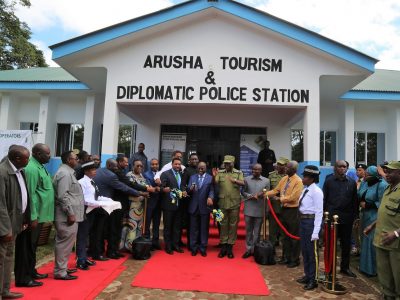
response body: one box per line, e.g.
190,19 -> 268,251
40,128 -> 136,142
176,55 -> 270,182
0,82 -> 90,91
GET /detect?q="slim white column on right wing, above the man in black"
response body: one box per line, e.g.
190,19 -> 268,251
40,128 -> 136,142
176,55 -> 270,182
338,103 -> 355,168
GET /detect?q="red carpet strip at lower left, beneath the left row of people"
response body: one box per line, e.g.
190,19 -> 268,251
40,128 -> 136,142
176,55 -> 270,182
11,255 -> 128,300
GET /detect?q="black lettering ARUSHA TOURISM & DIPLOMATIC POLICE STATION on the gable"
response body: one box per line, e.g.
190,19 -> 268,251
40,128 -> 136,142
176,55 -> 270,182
117,55 -> 310,103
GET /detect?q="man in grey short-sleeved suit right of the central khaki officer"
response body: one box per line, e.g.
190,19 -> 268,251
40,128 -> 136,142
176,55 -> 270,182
242,164 -> 270,258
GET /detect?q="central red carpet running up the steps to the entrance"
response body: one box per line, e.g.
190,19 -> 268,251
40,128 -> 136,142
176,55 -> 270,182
132,209 -> 270,295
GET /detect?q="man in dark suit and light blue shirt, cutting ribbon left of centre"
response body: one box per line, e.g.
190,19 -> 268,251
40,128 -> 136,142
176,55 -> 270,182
160,158 -> 187,254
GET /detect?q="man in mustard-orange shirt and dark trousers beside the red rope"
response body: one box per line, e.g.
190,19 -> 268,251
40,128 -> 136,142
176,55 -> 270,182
267,160 -> 303,268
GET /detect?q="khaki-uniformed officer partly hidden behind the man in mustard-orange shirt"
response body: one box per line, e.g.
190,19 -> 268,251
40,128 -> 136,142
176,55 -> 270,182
268,157 -> 289,250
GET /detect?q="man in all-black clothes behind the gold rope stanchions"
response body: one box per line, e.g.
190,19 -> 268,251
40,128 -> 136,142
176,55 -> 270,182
322,160 -> 358,277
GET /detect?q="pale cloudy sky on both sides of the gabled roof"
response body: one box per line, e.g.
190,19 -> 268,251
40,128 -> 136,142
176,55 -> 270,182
16,0 -> 400,71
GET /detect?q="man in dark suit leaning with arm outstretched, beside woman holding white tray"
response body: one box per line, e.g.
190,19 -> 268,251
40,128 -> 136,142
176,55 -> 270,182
93,158 -> 142,260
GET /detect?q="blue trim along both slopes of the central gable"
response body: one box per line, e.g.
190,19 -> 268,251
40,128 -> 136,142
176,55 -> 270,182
50,0 -> 378,72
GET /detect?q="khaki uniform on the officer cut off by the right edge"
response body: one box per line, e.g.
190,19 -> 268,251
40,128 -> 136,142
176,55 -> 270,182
374,184 -> 400,299
